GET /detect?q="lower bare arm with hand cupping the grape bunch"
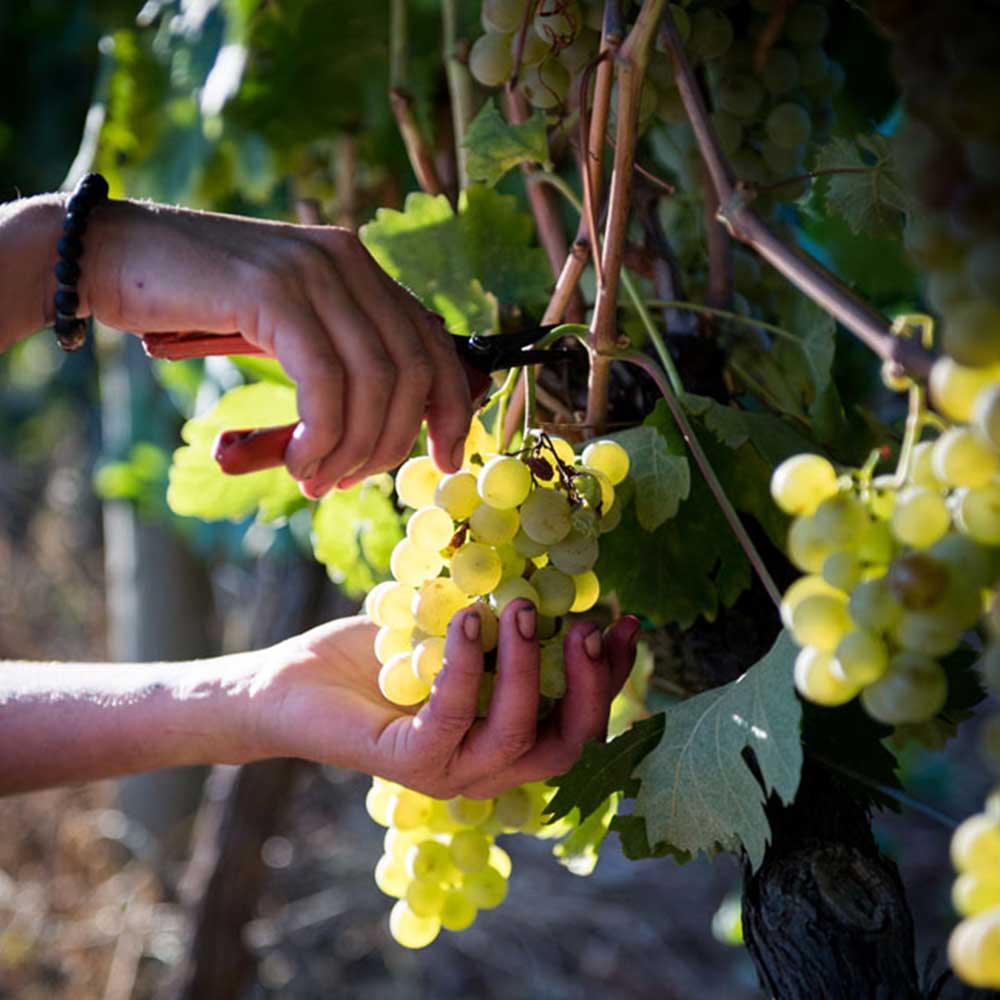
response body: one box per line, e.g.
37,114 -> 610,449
0,602 -> 638,798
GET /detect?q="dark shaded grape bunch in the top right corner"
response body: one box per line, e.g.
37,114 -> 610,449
871,0 -> 1000,365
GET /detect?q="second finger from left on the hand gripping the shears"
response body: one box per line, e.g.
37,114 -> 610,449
309,268 -> 397,487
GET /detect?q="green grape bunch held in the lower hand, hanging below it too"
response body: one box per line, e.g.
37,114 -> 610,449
365,420 -> 629,948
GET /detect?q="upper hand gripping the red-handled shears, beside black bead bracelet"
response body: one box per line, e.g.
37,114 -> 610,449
81,201 -> 472,497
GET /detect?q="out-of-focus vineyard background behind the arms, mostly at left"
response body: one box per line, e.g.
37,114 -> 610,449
0,0 -> 987,1000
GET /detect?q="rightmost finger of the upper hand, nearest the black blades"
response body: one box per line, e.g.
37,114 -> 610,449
421,312 -> 473,472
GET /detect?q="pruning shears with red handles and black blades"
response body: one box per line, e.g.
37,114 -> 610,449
142,326 -> 576,476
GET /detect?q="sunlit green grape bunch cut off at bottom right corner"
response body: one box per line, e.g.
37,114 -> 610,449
948,792 -> 1000,989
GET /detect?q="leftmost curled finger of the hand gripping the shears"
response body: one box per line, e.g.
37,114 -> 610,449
264,303 -> 344,481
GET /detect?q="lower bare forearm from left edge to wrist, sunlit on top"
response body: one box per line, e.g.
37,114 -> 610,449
0,653 -> 270,795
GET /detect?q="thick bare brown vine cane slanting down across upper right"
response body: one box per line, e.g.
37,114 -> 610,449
660,10 -> 934,379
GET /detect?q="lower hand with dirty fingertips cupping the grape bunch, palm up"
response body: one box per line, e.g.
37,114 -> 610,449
251,601 -> 639,799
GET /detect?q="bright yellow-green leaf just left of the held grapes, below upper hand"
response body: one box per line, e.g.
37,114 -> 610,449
312,482 -> 403,596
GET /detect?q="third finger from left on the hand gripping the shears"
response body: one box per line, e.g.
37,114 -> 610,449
339,270 -> 434,489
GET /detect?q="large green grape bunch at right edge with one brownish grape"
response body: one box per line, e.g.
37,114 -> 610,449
771,358 -> 1000,726
